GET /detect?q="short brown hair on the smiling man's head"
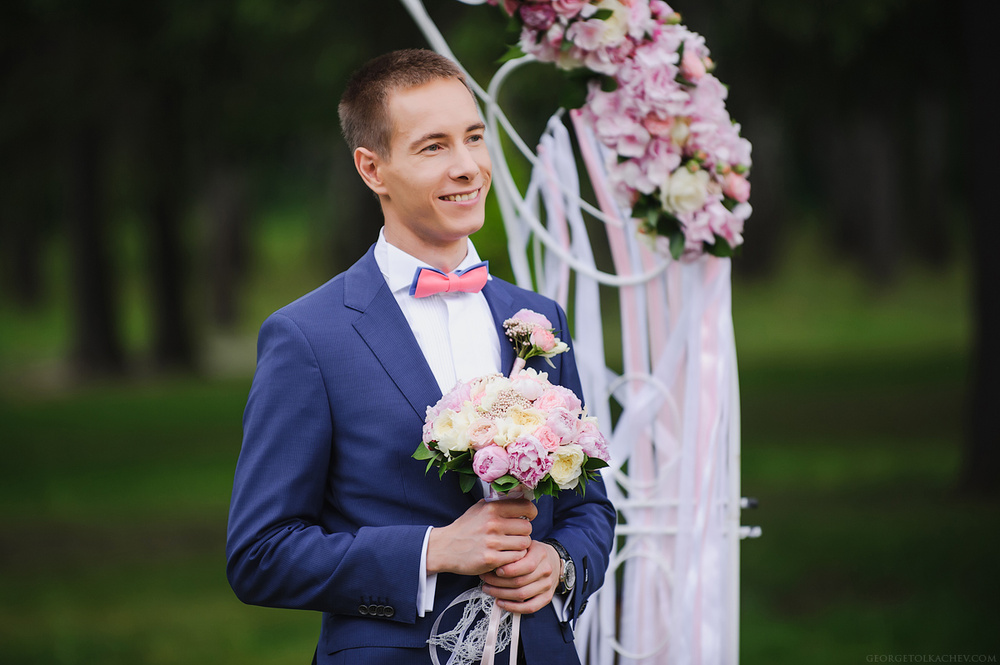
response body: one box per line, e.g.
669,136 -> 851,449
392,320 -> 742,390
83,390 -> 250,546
337,49 -> 475,157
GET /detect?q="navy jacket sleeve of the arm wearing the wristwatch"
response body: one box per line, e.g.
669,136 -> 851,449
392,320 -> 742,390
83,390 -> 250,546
545,306 -> 617,620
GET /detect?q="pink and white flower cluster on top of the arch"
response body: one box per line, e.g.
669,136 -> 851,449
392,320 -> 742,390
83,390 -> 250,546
488,0 -> 751,259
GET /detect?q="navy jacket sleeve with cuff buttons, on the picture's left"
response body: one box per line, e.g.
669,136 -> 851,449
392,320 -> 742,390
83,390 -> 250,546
226,313 -> 427,623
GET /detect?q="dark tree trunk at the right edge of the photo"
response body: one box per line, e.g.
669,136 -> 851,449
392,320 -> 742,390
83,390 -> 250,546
961,2 -> 1000,494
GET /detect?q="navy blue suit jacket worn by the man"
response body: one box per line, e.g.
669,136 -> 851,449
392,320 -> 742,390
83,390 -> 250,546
226,250 -> 615,665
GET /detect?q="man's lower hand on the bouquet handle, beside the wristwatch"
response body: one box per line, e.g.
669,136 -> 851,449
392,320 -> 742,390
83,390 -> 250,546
478,532 -> 562,614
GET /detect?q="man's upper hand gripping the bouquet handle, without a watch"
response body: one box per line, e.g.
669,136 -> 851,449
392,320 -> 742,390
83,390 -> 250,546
427,499 -> 540,577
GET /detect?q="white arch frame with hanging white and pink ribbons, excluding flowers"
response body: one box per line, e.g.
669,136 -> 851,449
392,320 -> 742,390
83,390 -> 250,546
401,0 -> 759,665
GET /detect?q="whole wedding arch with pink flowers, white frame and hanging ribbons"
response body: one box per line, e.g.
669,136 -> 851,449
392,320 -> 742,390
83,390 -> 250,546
401,0 -> 760,665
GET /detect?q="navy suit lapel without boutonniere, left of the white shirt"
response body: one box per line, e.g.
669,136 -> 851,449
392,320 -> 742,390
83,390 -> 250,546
344,244 -> 440,421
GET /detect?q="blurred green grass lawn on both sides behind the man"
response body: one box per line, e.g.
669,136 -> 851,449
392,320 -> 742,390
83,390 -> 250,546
0,233 -> 1000,665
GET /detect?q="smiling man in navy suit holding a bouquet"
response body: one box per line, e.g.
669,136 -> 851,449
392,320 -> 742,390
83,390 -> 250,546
227,50 -> 615,665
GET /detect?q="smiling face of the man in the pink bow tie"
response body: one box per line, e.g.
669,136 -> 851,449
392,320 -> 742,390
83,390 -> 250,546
376,79 -> 492,256
